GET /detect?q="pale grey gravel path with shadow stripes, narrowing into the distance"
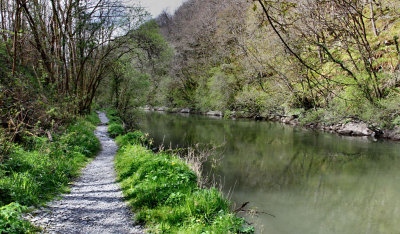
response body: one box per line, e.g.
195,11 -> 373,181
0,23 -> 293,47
27,112 -> 144,233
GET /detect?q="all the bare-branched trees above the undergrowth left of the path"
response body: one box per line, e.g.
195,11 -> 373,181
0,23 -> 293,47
0,0 -> 147,114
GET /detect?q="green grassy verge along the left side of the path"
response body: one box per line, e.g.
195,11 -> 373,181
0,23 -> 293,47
0,113 -> 100,233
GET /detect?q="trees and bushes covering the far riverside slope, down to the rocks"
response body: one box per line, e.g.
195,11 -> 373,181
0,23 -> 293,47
99,0 -> 400,139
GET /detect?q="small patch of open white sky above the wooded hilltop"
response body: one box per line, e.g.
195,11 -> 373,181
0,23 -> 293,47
131,0 -> 185,17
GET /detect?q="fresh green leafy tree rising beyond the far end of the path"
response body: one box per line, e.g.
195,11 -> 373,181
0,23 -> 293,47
97,20 -> 173,113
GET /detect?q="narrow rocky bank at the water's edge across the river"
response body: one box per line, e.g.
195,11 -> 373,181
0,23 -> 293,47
143,106 -> 400,141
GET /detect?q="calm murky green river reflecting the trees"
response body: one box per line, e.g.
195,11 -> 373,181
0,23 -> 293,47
138,112 -> 400,234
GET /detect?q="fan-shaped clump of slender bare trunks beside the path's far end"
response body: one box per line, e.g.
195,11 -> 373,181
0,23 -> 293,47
2,0 -> 147,113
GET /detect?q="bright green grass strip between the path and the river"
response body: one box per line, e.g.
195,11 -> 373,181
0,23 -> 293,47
116,131 -> 254,233
